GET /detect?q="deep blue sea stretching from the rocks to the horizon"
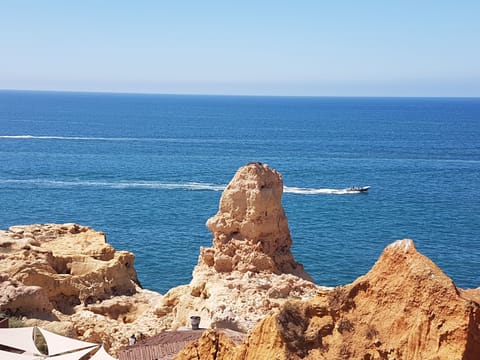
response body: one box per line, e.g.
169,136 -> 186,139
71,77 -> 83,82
0,91 -> 480,293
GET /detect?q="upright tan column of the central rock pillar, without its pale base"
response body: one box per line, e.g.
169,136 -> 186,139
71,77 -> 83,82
199,163 -> 311,281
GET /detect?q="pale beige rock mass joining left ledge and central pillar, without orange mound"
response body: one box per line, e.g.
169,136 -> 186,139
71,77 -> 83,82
0,163 -> 321,353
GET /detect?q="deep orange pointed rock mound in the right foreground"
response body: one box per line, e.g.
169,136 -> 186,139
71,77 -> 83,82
178,239 -> 480,360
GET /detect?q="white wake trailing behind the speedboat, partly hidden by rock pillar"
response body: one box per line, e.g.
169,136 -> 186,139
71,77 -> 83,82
0,179 -> 364,195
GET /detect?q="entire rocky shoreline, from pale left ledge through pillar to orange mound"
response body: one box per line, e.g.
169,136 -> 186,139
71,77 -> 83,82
0,163 -> 480,360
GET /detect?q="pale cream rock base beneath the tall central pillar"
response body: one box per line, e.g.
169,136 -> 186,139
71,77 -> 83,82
155,271 -> 321,332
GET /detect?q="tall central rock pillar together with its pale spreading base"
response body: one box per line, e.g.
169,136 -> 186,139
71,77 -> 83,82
156,163 -> 321,332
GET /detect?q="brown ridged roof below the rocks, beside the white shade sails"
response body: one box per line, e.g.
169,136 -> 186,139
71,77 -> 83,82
118,329 -> 245,360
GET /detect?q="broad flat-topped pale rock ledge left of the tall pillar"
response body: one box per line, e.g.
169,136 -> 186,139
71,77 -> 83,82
0,224 -> 165,353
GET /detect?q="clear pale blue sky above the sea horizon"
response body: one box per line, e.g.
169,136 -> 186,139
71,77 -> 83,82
0,0 -> 480,97
